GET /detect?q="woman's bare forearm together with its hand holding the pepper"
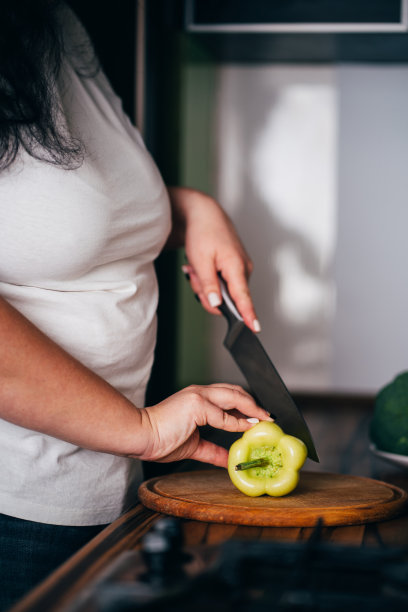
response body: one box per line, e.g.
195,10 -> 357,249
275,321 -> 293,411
0,298 -> 268,467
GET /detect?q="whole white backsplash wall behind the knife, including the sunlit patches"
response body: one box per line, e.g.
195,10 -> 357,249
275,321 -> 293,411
211,65 -> 408,392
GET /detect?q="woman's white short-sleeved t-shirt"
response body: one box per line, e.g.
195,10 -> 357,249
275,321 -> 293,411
0,8 -> 170,525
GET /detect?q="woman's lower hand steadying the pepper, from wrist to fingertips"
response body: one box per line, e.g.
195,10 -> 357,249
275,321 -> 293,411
137,384 -> 272,467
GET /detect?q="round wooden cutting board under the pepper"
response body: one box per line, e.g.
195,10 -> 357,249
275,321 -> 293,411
139,470 -> 408,527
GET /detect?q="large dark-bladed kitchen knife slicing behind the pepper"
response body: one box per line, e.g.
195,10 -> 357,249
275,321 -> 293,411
219,276 -> 319,462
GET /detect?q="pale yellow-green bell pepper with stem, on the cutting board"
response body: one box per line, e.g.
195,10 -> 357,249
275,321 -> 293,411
228,421 -> 307,497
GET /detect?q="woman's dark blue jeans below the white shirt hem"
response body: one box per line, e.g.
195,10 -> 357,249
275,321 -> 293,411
0,514 -> 105,612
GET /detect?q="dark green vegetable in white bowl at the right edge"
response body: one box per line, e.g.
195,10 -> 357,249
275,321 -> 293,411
370,372 -> 408,455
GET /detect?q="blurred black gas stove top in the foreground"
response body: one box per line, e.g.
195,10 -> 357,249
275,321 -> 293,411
66,519 -> 408,612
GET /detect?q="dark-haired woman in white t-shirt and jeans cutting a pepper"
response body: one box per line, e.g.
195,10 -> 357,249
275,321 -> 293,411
0,0 -> 267,609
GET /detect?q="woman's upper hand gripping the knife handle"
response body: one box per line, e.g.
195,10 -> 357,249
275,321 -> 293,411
168,187 -> 260,332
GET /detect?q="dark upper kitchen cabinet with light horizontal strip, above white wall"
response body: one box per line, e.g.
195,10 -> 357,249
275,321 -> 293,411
184,0 -> 408,63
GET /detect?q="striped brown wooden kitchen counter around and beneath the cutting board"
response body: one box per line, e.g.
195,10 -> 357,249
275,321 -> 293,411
8,397 -> 408,612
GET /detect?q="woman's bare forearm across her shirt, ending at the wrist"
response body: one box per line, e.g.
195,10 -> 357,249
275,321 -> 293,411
0,298 -> 144,455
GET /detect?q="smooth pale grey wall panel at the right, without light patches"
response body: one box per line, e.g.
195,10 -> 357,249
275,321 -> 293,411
333,66 -> 408,389
